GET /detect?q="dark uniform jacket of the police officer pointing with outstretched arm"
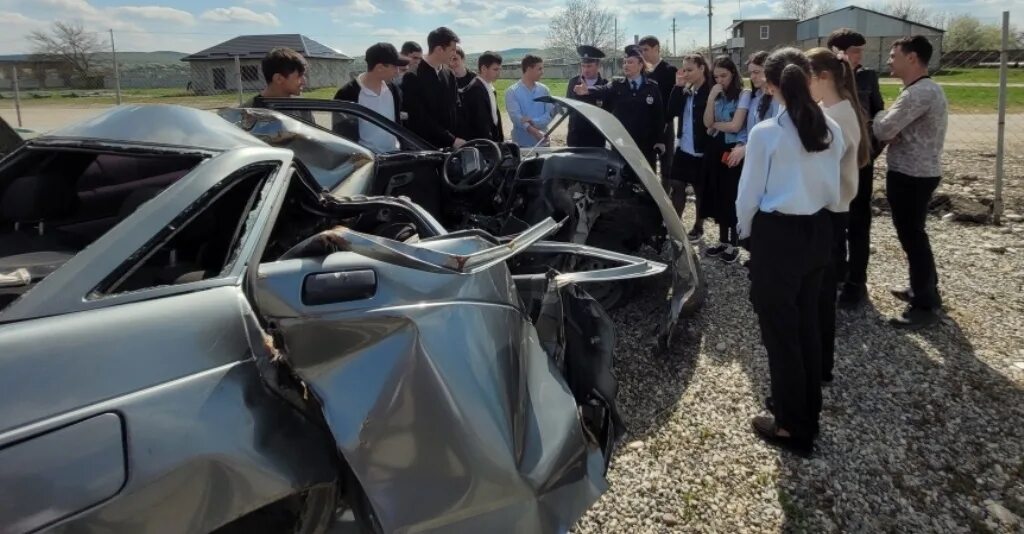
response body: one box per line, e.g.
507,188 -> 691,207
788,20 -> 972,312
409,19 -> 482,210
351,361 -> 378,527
582,76 -> 665,159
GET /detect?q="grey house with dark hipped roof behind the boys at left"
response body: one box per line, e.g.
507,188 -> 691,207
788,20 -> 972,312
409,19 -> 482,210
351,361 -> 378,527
181,34 -> 353,93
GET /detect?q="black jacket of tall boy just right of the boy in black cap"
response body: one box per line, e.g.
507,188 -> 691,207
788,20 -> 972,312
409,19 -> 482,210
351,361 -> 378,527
401,59 -> 459,149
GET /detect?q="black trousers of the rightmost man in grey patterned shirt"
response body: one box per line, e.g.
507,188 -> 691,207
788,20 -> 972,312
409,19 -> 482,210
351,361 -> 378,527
886,171 -> 942,309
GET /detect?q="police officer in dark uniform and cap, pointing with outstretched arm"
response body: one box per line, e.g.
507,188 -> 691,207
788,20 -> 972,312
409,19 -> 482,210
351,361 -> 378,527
572,44 -> 666,169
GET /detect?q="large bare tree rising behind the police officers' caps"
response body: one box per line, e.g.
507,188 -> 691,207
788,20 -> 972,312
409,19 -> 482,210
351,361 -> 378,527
547,0 -> 626,57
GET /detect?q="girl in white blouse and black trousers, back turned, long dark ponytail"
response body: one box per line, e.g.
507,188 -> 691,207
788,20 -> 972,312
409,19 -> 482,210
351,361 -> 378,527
736,48 -> 845,457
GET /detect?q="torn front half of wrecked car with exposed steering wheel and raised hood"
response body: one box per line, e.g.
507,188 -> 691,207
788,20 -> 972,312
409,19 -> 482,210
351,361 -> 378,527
220,97 -> 705,351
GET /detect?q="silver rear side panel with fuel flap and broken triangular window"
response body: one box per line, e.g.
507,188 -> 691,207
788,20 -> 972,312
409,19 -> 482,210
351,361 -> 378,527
0,148 -> 334,533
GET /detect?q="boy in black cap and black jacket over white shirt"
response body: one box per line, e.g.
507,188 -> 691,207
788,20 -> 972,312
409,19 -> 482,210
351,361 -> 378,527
332,43 -> 409,152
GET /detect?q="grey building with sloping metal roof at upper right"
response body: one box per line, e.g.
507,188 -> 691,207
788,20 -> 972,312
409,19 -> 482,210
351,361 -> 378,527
796,5 -> 945,72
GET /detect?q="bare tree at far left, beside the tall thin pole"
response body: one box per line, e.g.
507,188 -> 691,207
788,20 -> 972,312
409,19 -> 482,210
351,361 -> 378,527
29,20 -> 105,78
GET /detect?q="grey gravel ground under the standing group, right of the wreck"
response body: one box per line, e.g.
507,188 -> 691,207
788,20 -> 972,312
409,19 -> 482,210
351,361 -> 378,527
574,156 -> 1024,533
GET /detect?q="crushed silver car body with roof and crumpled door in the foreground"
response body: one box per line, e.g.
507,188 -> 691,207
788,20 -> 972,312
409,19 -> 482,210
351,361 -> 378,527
0,106 -> 666,533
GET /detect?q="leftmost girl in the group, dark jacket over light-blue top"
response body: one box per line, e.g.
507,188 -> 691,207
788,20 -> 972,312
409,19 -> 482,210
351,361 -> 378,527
667,54 -> 714,237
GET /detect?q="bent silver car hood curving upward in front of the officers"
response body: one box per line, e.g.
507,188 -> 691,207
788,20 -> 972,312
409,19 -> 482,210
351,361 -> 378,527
538,96 -> 687,243
